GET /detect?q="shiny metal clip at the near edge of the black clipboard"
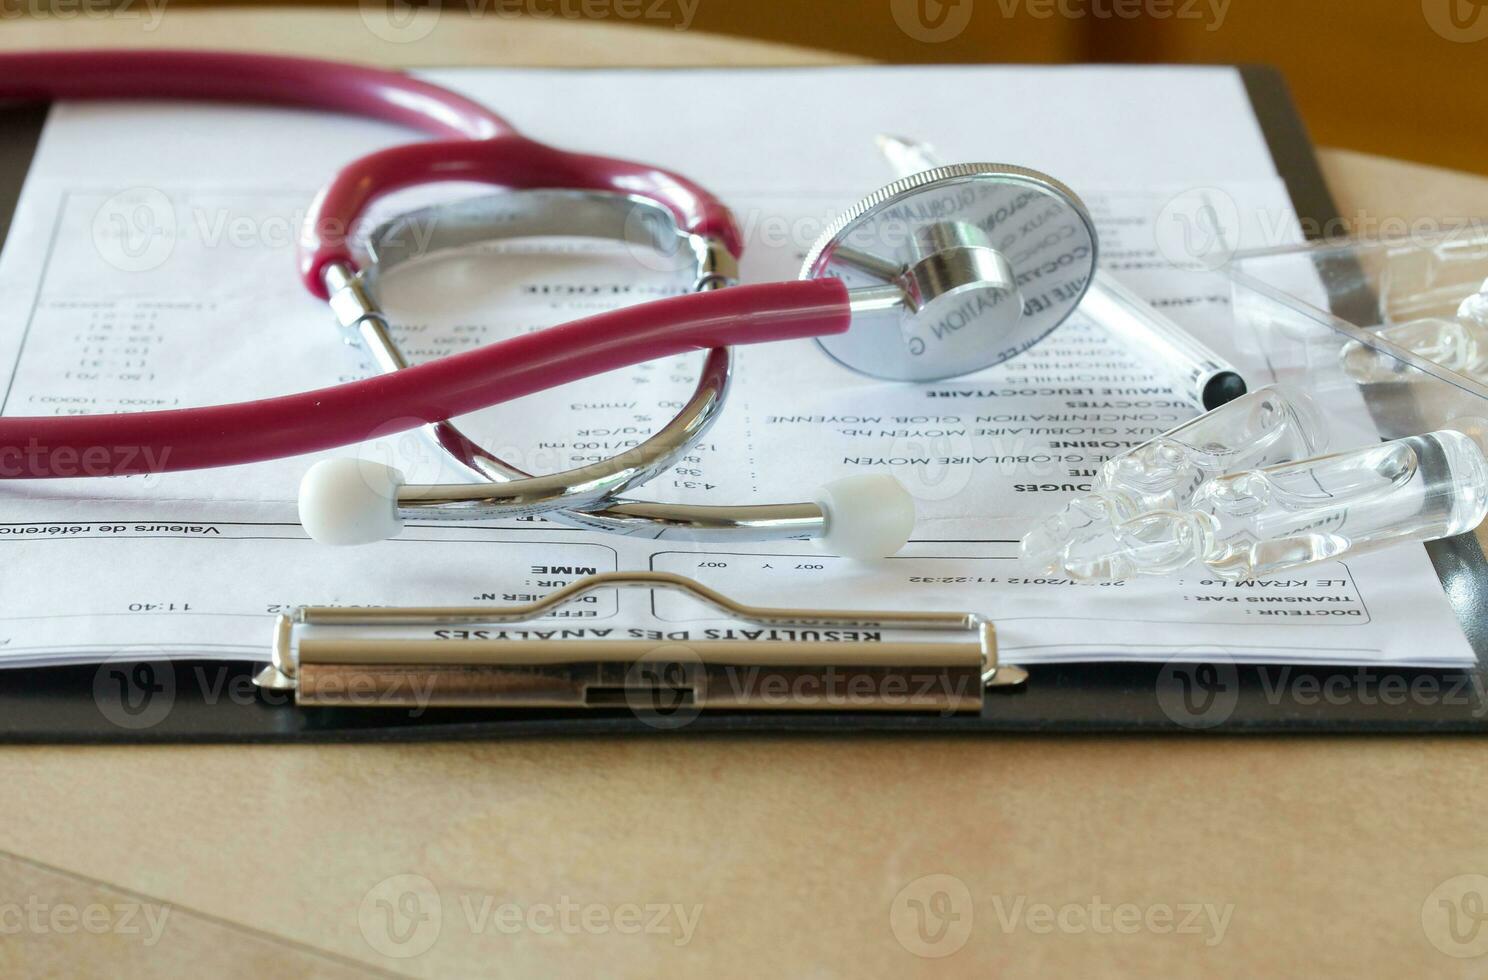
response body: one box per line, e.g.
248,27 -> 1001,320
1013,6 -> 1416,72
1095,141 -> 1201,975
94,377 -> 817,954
254,571 -> 1028,714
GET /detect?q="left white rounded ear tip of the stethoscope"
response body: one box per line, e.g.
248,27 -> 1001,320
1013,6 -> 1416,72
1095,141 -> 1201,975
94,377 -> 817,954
299,458 -> 403,546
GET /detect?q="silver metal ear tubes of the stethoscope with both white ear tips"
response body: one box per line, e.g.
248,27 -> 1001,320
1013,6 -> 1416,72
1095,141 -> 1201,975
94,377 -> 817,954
299,190 -> 914,561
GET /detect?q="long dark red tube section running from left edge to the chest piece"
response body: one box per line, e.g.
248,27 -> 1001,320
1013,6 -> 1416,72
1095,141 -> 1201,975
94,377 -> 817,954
0,280 -> 848,479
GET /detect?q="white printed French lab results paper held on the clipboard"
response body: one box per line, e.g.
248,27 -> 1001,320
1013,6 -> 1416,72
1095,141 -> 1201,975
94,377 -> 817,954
0,68 -> 1473,666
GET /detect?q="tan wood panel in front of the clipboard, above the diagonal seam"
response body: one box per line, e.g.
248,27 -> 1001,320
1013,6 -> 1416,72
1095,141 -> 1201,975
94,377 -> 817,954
0,738 -> 1488,977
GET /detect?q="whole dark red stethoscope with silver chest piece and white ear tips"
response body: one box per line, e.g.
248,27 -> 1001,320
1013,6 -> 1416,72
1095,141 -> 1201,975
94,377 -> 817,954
0,51 -> 1097,558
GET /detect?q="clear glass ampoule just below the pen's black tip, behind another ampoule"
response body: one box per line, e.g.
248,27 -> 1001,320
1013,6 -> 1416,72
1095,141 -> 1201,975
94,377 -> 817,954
1022,385 -> 1327,567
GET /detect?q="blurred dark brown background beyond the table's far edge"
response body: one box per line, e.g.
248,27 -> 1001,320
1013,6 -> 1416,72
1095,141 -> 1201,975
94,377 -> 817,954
695,0 -> 1488,173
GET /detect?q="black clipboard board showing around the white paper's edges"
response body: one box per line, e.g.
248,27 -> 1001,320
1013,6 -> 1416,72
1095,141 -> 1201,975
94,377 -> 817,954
0,65 -> 1488,744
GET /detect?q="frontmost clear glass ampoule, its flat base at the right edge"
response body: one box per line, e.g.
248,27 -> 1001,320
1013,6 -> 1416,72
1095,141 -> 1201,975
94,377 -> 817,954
1058,422 -> 1488,581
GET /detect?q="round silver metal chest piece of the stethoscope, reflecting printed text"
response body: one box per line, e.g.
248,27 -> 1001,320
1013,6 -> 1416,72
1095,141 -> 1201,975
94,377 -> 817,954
801,164 -> 1097,381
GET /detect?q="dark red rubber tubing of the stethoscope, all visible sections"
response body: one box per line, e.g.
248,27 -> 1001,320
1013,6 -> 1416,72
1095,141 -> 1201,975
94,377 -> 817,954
0,51 -> 827,479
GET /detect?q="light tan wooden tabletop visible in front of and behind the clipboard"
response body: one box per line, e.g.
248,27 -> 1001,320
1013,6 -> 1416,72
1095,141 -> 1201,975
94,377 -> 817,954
0,10 -> 1488,977
